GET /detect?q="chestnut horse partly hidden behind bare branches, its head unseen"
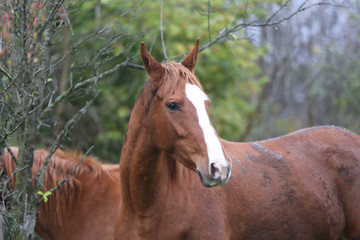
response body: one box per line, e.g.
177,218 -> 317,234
1,148 -> 120,240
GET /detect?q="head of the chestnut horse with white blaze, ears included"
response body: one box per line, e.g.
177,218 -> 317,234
141,39 -> 231,187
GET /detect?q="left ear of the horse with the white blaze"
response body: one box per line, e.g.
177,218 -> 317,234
140,42 -> 165,87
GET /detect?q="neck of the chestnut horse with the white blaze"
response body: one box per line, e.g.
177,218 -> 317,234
120,85 -> 188,215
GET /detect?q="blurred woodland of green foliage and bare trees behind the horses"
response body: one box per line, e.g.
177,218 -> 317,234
3,0 -> 360,163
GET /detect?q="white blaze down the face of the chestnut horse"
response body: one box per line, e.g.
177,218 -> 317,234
185,83 -> 227,172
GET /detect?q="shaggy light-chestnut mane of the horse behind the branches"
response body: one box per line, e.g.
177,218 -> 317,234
1,148 -> 118,226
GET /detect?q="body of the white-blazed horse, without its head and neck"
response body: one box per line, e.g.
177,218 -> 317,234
117,124 -> 360,240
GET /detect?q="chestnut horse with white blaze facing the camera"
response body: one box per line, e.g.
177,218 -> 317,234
115,38 -> 360,240
